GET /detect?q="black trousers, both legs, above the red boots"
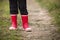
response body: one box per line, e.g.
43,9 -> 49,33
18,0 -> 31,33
9,0 -> 28,15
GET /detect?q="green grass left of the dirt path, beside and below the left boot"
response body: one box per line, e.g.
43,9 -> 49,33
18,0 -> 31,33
0,0 -> 22,40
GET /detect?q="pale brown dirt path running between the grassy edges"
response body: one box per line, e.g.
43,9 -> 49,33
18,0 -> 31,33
21,0 -> 56,40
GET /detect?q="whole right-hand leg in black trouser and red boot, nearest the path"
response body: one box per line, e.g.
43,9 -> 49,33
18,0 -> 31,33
18,0 -> 31,31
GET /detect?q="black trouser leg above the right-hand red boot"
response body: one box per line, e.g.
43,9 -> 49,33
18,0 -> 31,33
18,0 -> 28,15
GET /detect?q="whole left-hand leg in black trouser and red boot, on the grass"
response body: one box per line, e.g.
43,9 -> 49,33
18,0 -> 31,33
9,0 -> 18,29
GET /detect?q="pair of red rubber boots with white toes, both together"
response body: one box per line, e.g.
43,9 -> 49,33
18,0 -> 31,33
9,14 -> 31,31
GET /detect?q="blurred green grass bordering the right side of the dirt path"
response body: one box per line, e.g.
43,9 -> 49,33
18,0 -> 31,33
36,0 -> 60,32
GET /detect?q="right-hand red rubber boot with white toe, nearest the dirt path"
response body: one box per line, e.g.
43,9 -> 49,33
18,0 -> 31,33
21,15 -> 31,31
